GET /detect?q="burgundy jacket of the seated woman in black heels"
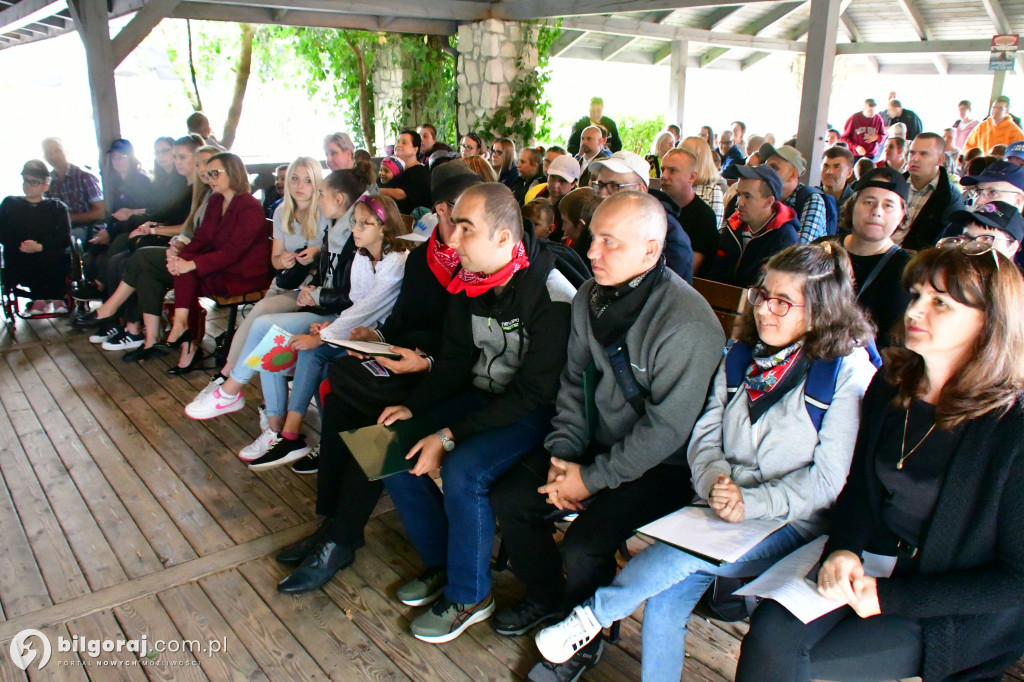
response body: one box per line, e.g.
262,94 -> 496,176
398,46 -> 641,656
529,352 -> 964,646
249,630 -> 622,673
178,193 -> 273,296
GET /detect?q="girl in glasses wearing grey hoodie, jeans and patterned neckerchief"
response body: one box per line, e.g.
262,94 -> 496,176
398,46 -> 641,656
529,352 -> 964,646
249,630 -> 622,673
537,244 -> 874,682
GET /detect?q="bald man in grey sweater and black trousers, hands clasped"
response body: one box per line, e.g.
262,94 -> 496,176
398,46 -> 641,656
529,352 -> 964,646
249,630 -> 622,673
492,190 -> 725,679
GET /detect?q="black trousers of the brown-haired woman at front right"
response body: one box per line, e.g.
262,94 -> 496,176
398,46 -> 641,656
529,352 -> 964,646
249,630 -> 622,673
736,600 -> 924,682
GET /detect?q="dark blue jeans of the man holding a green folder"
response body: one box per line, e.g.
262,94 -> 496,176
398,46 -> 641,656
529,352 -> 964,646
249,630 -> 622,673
384,393 -> 553,604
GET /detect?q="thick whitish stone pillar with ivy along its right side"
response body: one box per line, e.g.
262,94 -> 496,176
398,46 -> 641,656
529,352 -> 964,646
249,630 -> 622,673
457,19 -> 539,140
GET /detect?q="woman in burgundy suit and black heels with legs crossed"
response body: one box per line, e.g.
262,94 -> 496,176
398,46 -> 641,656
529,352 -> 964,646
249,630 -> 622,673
163,152 -> 273,370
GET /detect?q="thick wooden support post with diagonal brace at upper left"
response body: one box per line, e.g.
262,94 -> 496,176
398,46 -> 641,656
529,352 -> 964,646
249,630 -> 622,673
68,0 -> 121,187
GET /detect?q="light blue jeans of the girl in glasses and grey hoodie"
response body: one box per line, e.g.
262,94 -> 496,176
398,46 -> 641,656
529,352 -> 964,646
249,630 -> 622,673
587,525 -> 807,682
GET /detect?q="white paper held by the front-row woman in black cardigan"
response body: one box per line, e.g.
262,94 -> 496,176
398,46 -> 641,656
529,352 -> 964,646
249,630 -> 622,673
733,536 -> 896,624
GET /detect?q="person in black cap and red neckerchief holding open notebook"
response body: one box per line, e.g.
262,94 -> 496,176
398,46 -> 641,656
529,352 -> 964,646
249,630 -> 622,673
274,163 -> 482,594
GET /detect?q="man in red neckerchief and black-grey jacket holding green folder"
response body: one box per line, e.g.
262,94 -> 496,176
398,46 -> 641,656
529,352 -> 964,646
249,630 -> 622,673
378,180 -> 575,643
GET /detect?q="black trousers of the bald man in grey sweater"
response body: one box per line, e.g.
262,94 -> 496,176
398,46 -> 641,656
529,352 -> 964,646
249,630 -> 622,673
490,451 -> 693,609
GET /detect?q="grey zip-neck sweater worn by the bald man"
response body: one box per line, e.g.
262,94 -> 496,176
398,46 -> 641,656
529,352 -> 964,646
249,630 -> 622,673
544,268 -> 725,493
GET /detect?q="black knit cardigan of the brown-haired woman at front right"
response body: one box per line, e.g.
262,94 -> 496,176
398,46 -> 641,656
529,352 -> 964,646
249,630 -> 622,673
823,373 -> 1024,682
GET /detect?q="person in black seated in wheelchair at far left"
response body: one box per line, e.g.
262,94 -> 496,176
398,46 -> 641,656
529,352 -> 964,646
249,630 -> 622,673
0,161 -> 71,315
